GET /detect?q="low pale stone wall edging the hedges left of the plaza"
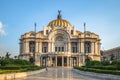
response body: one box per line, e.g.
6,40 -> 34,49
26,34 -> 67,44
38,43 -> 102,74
0,69 -> 45,80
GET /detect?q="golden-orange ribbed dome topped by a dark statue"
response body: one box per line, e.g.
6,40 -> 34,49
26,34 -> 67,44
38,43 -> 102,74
48,11 -> 71,27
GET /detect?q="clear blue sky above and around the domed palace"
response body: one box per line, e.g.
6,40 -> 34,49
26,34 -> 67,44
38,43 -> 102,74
0,0 -> 120,55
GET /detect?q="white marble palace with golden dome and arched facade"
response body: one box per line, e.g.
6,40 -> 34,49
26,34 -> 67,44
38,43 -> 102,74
19,11 -> 101,67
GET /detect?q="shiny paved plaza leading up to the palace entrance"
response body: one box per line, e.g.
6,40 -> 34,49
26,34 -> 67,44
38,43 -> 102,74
16,68 -> 103,80
